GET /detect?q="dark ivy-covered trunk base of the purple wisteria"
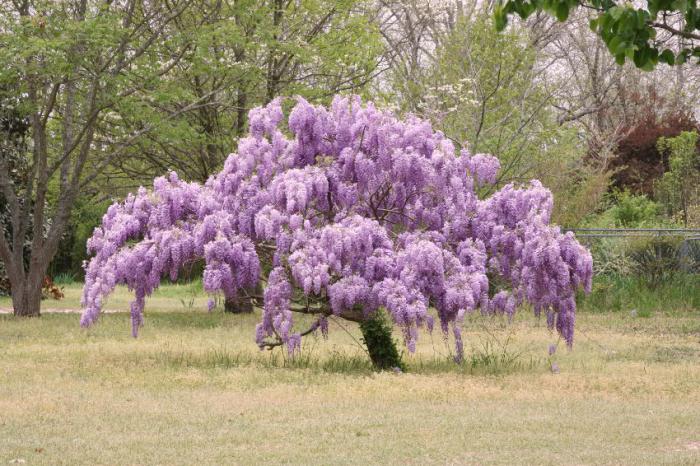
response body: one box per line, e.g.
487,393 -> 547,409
360,311 -> 406,371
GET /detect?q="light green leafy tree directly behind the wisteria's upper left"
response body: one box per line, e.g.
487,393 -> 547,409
107,0 -> 384,189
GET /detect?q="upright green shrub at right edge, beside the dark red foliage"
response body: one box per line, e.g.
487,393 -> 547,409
656,131 -> 700,226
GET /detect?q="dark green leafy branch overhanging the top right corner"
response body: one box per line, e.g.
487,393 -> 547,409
495,0 -> 700,71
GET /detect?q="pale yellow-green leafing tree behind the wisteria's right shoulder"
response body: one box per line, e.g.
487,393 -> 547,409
418,10 -> 609,225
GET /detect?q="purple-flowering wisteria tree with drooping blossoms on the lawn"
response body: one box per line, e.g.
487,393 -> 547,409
81,97 -> 592,368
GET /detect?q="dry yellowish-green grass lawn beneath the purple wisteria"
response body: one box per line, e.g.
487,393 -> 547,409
0,285 -> 700,465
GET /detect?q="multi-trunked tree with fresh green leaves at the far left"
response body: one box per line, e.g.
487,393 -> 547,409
0,0 -> 203,316
